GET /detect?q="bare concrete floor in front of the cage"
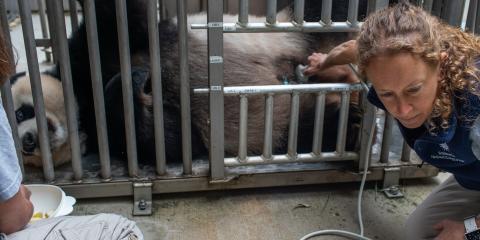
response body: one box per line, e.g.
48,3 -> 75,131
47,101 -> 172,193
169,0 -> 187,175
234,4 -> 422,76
73,173 -> 448,240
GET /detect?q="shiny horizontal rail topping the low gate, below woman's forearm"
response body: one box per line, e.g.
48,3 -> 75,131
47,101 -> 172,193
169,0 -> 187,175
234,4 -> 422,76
193,83 -> 362,96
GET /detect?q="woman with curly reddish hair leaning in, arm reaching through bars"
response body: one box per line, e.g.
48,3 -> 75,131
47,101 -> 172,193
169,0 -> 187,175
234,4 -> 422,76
305,3 -> 480,240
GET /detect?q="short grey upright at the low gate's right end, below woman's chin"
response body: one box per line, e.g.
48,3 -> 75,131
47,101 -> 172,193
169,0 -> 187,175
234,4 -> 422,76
358,91 -> 376,171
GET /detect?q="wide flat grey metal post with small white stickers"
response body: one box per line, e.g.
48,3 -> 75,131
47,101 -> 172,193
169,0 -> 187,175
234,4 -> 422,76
207,0 -> 225,180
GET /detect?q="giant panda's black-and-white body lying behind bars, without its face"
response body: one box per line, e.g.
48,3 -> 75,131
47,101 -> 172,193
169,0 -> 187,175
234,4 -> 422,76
13,0 -> 368,165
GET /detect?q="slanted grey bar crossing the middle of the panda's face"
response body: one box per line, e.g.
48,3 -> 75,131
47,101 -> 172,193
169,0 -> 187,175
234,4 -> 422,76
18,0 -> 55,181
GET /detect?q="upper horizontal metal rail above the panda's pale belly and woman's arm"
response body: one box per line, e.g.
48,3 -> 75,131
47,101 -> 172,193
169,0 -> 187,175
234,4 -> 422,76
190,22 -> 362,33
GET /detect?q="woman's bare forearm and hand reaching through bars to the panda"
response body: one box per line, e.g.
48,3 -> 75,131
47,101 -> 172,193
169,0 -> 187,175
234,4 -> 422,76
304,40 -> 357,75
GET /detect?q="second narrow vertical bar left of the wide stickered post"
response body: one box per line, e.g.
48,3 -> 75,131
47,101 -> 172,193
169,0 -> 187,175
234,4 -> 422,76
147,0 -> 167,175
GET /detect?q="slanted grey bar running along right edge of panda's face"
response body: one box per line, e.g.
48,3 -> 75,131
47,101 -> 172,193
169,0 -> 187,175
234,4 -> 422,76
47,0 -> 83,180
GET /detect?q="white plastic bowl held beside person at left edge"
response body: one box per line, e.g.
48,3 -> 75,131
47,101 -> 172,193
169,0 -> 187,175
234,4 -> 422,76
25,184 -> 76,217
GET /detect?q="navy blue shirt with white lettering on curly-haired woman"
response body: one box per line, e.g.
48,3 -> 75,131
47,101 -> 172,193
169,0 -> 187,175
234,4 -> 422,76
368,87 -> 480,190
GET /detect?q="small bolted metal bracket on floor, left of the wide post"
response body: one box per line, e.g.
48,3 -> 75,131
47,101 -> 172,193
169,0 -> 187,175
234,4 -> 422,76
133,182 -> 153,216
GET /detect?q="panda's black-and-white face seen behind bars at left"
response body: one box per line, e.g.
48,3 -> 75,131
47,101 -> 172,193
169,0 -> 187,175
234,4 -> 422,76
12,75 -> 86,167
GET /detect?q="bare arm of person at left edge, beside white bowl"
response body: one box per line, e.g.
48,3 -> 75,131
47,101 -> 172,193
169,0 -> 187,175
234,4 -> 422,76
0,185 -> 33,235
